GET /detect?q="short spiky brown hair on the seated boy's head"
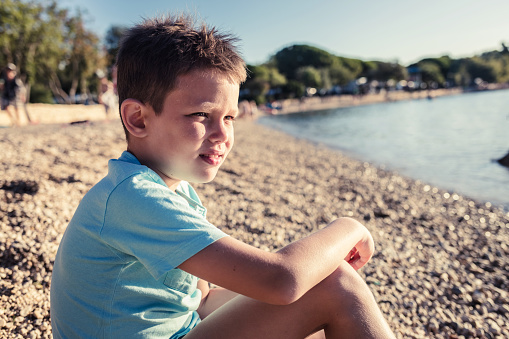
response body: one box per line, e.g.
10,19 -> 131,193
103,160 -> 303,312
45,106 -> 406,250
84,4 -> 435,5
117,14 -> 246,129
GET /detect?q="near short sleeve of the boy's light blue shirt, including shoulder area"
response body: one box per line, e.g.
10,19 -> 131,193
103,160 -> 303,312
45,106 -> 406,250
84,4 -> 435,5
101,177 -> 226,279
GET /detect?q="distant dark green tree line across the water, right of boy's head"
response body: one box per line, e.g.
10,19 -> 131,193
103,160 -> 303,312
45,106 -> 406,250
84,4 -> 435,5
241,44 -> 509,103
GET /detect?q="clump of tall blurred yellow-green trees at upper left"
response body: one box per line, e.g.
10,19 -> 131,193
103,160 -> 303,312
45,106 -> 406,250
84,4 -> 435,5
0,0 -> 102,103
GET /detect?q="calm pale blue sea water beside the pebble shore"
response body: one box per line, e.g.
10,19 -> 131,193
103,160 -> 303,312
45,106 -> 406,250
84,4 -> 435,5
259,90 -> 509,210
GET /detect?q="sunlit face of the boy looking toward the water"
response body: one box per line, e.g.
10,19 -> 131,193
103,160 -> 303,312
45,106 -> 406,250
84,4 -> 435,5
145,70 -> 239,190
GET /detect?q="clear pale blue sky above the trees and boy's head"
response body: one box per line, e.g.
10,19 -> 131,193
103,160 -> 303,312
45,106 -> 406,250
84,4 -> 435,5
59,0 -> 509,65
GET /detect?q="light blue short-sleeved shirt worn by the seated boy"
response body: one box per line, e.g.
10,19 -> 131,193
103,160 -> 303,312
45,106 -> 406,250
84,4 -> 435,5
51,152 -> 226,338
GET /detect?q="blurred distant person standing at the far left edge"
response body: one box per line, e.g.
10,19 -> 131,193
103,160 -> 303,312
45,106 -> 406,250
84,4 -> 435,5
0,63 -> 32,126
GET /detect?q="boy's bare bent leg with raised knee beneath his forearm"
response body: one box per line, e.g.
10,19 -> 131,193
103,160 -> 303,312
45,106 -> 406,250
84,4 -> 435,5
186,262 -> 394,339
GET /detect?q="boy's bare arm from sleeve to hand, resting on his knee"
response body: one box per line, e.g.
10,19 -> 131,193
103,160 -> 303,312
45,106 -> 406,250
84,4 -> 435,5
179,218 -> 374,304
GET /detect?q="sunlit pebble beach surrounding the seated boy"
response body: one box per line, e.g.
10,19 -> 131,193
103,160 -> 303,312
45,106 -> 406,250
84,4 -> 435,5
0,110 -> 509,338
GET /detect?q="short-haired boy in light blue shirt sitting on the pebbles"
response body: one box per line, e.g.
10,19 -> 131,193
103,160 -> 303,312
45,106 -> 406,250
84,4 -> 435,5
51,16 -> 394,339
